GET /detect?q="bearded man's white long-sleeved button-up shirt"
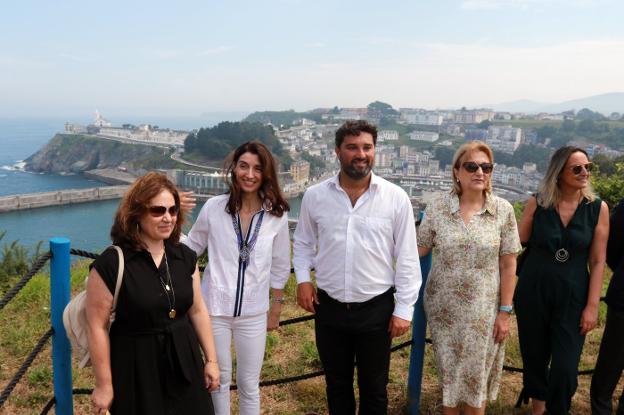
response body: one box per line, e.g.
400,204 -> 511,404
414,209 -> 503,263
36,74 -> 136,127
293,174 -> 422,320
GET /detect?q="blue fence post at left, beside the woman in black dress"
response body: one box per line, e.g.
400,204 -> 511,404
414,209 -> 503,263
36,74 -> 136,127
50,238 -> 74,415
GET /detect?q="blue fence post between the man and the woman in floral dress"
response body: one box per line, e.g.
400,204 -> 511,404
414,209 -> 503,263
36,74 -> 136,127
407,211 -> 431,415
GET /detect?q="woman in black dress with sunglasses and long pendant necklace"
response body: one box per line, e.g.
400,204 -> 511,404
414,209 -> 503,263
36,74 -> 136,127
87,173 -> 219,415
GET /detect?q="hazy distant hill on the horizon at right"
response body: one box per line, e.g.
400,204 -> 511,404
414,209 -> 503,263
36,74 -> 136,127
484,92 -> 624,115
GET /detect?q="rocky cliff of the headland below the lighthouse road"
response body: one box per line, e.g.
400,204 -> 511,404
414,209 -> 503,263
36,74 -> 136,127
25,134 -> 173,173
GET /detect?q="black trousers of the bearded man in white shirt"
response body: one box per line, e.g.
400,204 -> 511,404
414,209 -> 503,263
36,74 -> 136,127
315,289 -> 394,415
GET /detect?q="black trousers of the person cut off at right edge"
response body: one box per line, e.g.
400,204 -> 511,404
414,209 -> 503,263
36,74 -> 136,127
590,307 -> 624,415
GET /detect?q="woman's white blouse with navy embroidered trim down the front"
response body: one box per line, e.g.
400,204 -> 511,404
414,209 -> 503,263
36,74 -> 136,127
182,194 -> 290,316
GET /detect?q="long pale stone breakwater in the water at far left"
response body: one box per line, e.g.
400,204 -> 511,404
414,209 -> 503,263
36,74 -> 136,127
0,185 -> 129,212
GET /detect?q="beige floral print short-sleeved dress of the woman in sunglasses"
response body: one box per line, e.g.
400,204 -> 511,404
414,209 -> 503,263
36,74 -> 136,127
418,194 -> 521,407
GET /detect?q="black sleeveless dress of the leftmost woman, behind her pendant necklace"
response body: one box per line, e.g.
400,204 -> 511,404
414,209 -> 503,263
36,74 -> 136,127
91,243 -> 214,415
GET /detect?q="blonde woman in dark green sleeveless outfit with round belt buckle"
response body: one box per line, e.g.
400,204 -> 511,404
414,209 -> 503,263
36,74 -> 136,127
514,146 -> 609,415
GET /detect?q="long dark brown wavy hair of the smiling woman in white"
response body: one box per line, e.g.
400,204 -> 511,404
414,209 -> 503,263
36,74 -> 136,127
225,140 -> 290,217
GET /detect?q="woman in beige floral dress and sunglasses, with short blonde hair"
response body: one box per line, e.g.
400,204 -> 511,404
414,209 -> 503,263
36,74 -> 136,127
418,141 -> 521,415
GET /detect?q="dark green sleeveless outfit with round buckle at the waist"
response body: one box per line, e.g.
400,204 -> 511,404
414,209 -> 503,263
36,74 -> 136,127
514,199 -> 601,414
